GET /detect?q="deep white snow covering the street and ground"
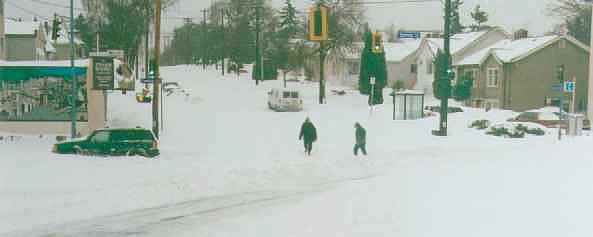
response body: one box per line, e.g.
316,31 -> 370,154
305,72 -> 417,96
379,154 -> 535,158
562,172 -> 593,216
0,66 -> 593,237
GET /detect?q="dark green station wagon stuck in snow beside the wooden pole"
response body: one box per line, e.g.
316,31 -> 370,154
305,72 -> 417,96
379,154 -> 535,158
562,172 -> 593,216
53,128 -> 160,157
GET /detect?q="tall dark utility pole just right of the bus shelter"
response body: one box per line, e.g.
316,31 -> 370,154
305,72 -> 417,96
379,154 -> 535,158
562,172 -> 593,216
433,0 -> 453,136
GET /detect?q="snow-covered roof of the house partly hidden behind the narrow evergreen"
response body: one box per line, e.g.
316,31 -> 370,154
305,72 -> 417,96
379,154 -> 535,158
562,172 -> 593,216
345,39 -> 422,62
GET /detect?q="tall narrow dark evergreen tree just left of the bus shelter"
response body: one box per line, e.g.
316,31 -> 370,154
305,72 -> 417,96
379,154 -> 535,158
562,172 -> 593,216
358,32 -> 387,104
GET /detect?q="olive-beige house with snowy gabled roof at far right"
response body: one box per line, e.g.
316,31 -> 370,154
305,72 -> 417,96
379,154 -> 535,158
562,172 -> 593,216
454,34 -> 589,111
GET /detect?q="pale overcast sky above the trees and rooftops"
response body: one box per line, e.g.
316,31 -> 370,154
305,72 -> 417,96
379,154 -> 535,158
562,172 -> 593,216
5,0 -> 558,34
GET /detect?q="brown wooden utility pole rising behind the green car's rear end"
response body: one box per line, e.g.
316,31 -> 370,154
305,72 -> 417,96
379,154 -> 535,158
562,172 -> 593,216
152,0 -> 161,138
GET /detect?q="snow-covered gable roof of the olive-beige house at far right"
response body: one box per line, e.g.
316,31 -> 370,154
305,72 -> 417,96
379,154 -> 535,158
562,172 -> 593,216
455,35 -> 589,66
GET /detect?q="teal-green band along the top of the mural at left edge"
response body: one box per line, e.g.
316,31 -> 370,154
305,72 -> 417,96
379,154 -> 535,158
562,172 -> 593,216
0,66 -> 87,81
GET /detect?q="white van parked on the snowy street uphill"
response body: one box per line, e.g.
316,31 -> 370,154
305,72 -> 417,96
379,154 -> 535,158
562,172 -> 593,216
268,89 -> 303,112
